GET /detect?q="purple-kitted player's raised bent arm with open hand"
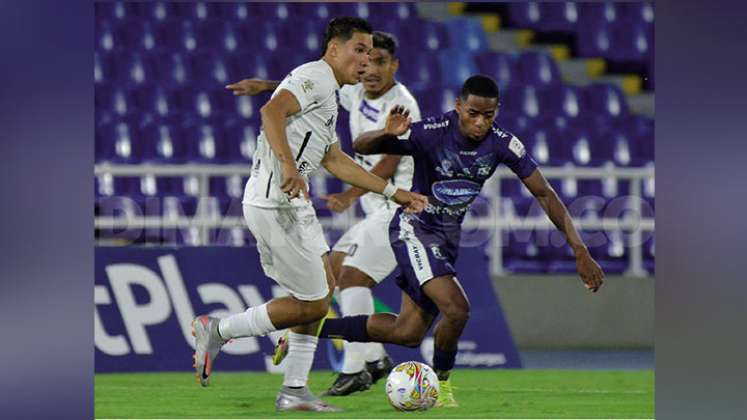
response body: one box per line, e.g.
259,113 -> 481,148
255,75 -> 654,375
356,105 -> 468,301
353,105 -> 412,155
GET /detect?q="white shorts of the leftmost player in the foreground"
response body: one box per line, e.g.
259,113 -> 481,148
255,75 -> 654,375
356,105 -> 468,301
244,204 -> 329,301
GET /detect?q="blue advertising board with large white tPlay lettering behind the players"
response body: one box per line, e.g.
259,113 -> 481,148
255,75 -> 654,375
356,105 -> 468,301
94,247 -> 521,372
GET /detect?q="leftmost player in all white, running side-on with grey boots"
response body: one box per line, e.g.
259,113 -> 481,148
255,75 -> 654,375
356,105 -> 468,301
192,17 -> 426,411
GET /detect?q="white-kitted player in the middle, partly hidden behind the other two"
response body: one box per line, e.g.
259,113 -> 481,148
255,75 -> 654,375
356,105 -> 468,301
229,32 -> 420,396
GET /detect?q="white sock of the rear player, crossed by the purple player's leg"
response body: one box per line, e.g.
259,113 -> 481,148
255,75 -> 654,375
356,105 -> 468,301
340,287 -> 384,373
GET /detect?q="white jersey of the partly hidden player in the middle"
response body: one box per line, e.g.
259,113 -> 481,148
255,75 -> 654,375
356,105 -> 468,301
340,83 -> 420,215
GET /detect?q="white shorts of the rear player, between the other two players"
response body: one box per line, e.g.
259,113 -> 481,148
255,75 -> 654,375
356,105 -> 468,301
332,208 -> 397,283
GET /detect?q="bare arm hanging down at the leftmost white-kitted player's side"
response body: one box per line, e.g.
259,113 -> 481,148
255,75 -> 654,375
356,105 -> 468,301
259,89 -> 309,200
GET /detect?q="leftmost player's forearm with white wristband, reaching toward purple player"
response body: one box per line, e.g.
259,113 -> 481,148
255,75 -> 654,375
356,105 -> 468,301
322,143 -> 428,213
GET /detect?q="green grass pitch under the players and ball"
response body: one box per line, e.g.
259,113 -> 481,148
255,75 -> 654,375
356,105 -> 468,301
95,369 -> 654,419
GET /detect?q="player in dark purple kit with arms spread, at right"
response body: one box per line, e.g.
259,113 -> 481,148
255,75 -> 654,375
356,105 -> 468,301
312,75 -> 604,406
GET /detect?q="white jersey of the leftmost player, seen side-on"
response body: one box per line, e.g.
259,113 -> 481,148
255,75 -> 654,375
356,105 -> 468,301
243,60 -> 340,208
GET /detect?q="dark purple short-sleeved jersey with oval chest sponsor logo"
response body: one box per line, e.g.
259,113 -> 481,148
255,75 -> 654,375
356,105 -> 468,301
382,111 -> 537,231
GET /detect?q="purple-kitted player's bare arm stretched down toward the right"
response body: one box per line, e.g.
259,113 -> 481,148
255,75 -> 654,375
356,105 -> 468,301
521,169 -> 604,292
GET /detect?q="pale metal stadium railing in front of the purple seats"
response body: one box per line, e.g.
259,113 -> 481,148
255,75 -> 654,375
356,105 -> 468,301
94,163 -> 655,277
